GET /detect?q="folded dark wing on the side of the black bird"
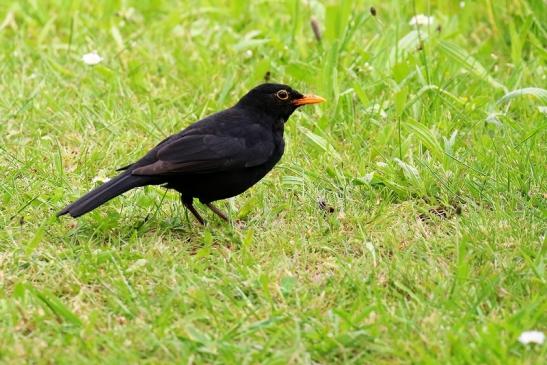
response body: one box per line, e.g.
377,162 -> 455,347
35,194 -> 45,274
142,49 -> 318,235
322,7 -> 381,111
132,133 -> 275,176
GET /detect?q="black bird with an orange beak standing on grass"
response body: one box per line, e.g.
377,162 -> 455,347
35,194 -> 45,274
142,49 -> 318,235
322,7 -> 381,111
57,83 -> 325,224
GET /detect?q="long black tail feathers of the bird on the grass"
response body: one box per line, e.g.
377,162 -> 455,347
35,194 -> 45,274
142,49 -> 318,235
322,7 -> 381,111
57,172 -> 150,218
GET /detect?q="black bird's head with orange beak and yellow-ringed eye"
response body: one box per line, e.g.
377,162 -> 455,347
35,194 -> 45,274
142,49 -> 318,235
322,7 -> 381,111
237,84 -> 325,121
